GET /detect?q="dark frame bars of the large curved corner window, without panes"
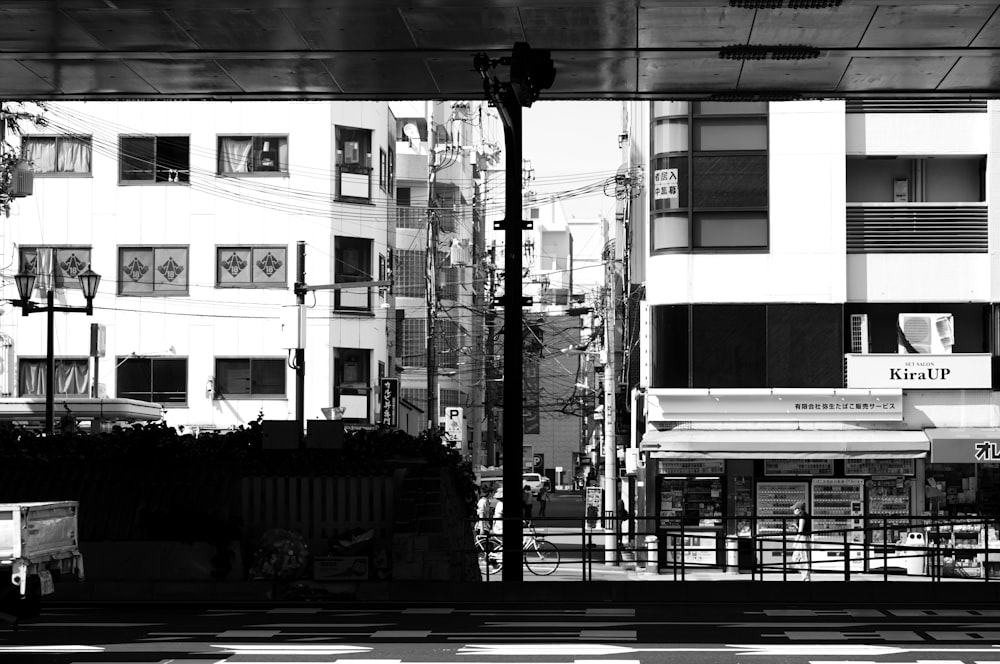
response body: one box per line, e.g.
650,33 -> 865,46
649,102 -> 771,256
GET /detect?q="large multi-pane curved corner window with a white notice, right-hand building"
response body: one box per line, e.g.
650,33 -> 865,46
650,102 -> 768,251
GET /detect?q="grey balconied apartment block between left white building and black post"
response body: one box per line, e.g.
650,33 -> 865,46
390,101 -> 503,465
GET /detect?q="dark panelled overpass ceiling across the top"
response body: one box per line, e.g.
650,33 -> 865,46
0,0 -> 1000,100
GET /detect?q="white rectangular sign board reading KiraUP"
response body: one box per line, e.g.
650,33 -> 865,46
847,353 -> 993,390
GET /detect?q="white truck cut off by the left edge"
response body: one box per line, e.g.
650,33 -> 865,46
0,500 -> 83,619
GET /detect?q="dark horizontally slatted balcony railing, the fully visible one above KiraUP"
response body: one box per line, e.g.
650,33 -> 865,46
847,203 -> 989,254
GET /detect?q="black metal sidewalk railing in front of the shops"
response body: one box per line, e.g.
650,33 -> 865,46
470,512 -> 1000,582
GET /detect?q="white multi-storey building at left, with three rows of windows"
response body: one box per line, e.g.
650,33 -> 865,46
0,101 -> 396,429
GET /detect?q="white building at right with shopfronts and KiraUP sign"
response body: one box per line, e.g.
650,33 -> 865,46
625,100 -> 1000,576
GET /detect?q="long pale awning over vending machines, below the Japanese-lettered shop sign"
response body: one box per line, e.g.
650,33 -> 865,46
639,429 -> 929,459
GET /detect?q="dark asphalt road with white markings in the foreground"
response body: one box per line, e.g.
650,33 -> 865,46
0,602 -> 1000,664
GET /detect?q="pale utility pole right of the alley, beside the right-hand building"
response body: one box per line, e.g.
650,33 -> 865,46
601,219 -> 618,565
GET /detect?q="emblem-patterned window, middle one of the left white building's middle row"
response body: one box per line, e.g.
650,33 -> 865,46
118,245 -> 189,295
